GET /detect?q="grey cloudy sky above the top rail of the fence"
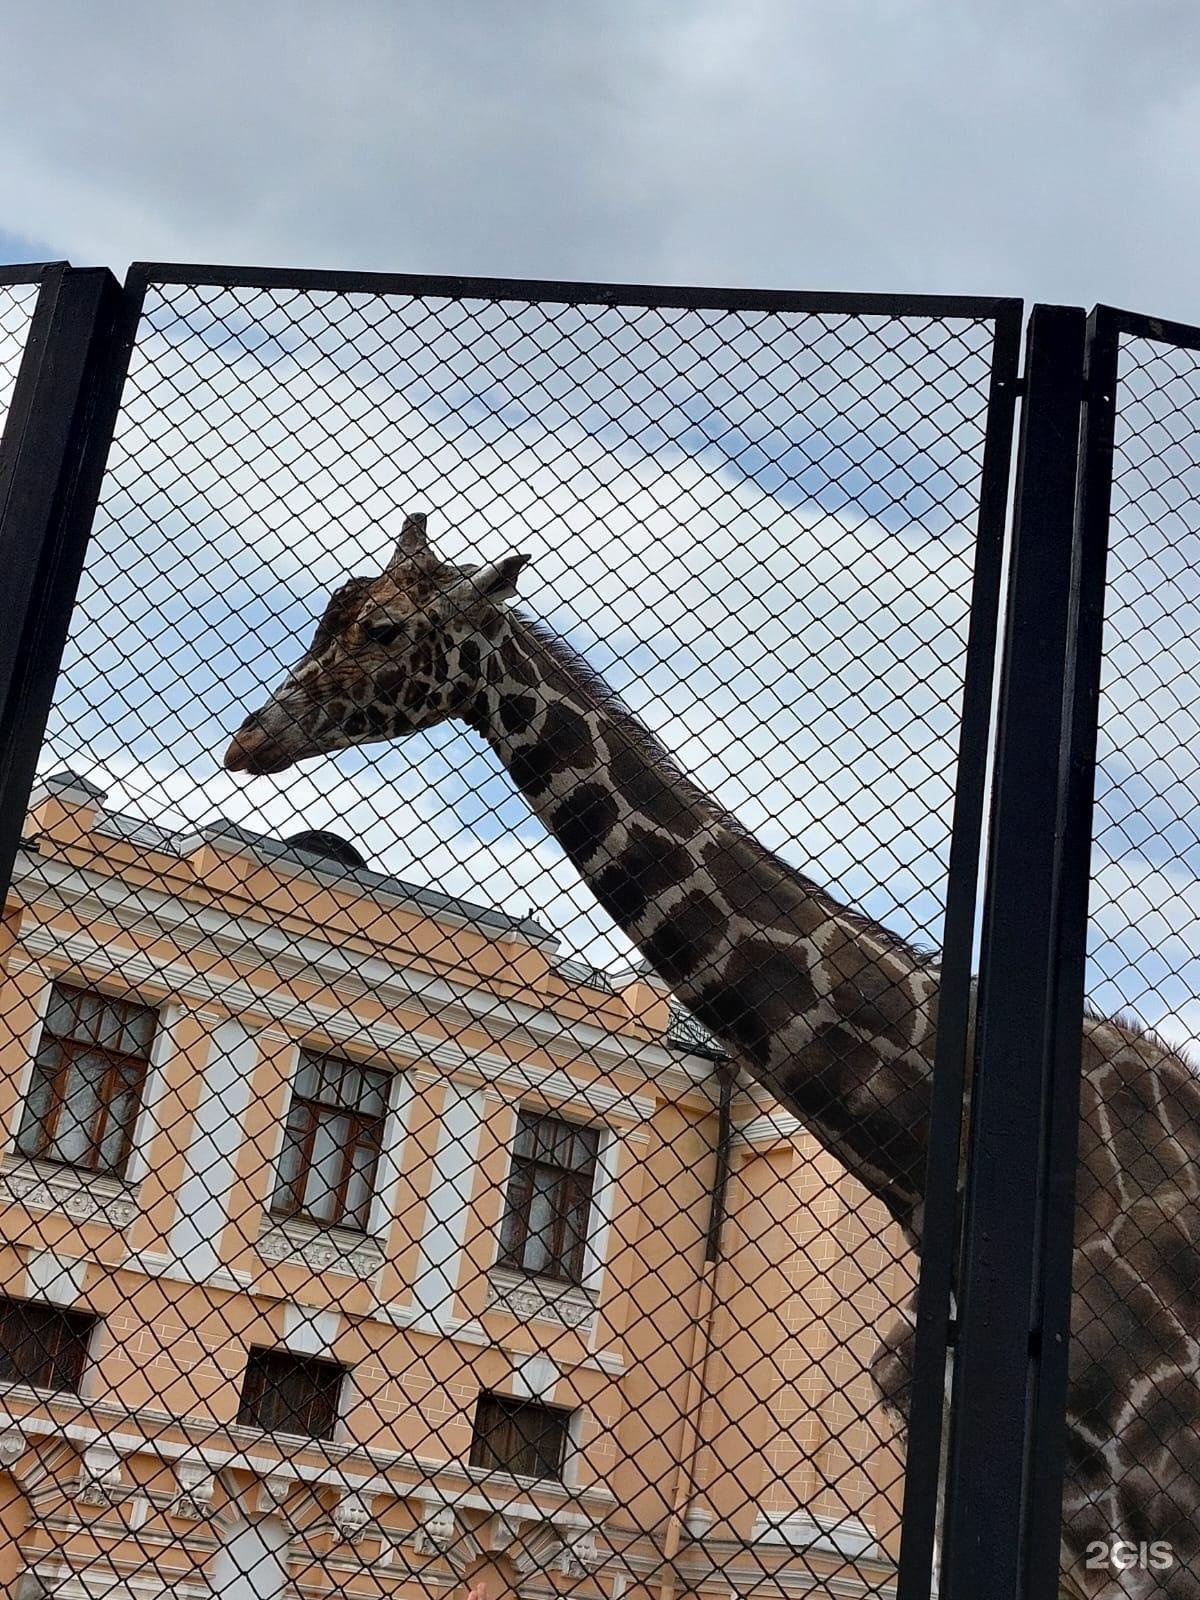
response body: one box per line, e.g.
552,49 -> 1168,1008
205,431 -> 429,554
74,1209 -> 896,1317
0,0 -> 1200,320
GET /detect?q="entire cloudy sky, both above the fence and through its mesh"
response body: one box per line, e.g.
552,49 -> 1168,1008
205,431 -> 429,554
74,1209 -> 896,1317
0,0 -> 1200,1037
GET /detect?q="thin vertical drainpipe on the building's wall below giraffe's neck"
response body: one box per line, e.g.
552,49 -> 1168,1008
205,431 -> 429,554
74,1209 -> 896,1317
659,1061 -> 738,1600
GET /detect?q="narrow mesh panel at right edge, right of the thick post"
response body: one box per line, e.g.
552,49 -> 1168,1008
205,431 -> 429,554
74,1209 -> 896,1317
1067,338 -> 1200,1595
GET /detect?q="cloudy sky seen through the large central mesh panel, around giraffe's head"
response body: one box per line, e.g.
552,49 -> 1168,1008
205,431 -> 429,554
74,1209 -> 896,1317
43,288 -> 989,960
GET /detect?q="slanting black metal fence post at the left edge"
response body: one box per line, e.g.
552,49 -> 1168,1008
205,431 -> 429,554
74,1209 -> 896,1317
0,267 -> 130,893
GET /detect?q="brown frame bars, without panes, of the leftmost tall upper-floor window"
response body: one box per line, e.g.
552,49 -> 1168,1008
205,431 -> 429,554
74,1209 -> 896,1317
11,978 -> 162,1182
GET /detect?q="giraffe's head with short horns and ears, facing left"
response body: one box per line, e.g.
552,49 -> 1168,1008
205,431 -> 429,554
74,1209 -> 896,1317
226,514 -> 528,774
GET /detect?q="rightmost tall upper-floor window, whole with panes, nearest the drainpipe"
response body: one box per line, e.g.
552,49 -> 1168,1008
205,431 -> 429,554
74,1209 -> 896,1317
499,1110 -> 600,1283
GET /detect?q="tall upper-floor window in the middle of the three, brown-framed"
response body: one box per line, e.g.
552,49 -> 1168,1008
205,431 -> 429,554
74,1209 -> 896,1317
270,1051 -> 392,1232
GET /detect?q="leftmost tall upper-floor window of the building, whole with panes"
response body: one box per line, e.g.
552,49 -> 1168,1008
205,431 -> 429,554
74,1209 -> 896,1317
16,984 -> 158,1178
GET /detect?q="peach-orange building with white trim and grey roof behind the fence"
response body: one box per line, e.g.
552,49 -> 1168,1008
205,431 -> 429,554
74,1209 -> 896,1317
0,774 -> 912,1600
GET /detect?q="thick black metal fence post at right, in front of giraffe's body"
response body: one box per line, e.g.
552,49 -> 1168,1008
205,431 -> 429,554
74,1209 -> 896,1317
942,306 -> 1086,1600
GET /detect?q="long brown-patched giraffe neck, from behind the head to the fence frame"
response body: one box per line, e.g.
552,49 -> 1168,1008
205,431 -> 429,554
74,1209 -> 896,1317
469,613 -> 936,1234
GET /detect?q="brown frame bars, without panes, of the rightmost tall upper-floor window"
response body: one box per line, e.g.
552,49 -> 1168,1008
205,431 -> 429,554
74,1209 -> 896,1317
496,1107 -> 603,1288
